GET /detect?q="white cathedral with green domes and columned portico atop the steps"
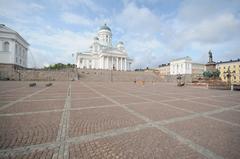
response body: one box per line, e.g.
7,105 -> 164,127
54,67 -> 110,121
76,24 -> 133,71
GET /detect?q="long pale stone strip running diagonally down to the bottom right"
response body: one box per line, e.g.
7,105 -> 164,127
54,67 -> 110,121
84,83 -> 223,159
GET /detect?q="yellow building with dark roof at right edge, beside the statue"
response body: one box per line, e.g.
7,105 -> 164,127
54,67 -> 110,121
216,59 -> 240,84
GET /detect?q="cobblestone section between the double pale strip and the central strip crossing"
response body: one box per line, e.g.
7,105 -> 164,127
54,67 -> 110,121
69,107 -> 143,137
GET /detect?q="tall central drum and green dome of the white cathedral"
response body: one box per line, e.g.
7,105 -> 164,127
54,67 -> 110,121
98,24 -> 112,47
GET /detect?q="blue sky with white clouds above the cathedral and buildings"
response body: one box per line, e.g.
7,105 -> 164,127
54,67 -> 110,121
0,0 -> 240,68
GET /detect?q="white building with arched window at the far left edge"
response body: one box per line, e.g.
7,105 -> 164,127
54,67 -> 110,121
0,24 -> 29,68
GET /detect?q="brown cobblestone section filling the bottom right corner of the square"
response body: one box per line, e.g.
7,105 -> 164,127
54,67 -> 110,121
167,117 -> 240,159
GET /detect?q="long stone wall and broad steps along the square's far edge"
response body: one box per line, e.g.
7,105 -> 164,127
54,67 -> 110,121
0,65 -> 195,83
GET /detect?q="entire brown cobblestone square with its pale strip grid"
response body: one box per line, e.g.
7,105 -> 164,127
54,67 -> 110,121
0,81 -> 240,159
